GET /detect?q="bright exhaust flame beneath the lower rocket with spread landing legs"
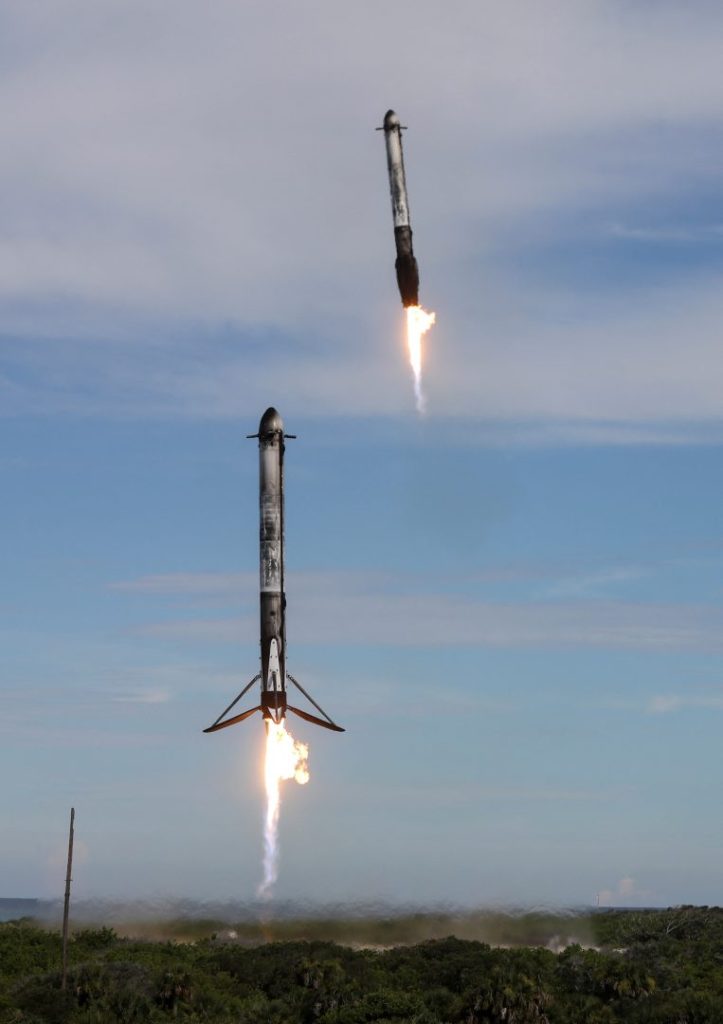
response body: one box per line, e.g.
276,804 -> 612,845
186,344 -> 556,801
258,719 -> 309,899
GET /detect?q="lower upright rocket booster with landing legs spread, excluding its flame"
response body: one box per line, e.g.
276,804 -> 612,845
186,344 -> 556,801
204,409 -> 344,732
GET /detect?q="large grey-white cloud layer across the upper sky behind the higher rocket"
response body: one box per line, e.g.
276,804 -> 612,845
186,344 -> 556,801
0,0 -> 723,430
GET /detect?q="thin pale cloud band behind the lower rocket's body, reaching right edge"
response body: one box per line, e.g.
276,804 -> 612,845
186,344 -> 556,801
118,571 -> 723,651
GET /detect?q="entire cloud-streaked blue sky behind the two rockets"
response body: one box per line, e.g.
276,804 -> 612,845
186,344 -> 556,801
0,0 -> 723,904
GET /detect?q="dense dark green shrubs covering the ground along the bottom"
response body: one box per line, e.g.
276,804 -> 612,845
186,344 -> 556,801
0,907 -> 723,1024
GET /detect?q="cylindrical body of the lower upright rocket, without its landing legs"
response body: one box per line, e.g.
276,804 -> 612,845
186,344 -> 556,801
258,409 -> 286,717
